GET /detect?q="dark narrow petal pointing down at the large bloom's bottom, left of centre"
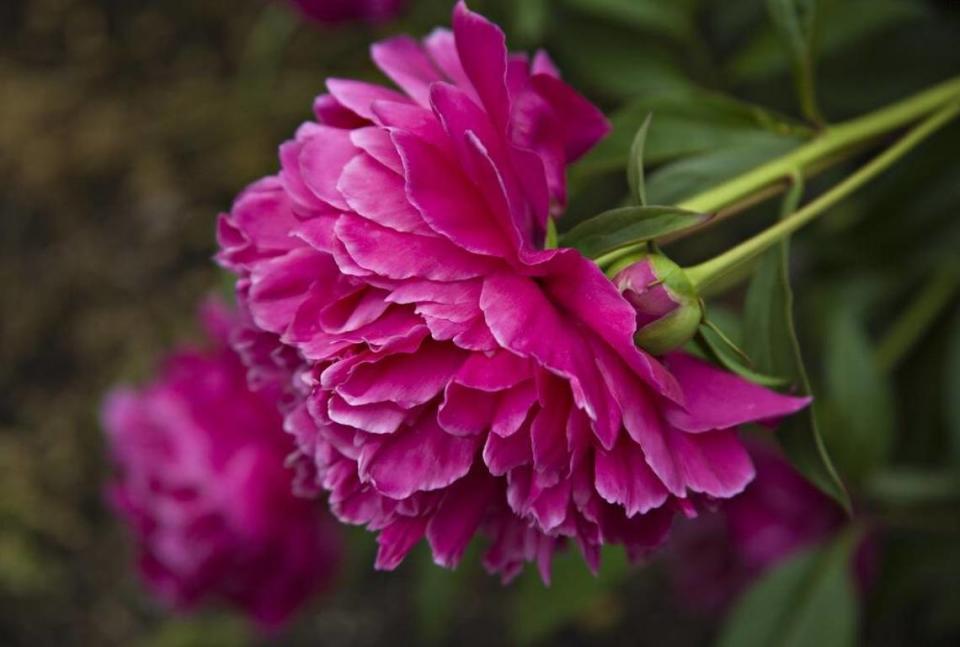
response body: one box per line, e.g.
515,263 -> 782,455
427,472 -> 496,568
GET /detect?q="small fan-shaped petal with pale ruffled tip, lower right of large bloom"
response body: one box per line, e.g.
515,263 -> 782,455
594,441 -> 668,517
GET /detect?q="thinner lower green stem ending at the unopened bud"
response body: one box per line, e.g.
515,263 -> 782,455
684,101 -> 960,290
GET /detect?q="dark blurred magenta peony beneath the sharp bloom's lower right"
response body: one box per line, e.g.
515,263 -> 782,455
667,442 -> 876,612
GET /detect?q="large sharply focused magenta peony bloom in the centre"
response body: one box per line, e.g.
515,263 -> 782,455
218,3 -> 807,579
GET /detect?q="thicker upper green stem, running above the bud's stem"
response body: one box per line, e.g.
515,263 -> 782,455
677,77 -> 960,213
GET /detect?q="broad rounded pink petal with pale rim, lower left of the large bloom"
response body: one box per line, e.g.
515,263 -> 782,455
367,417 -> 478,499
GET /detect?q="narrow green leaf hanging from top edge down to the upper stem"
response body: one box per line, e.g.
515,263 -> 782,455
767,0 -> 823,123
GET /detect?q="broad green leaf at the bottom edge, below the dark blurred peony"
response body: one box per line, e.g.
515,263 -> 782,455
718,530 -> 858,647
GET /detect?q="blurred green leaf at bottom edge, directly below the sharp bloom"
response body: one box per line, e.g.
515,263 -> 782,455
510,548 -> 630,645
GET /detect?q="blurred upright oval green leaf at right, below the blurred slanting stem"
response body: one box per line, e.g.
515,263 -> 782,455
824,304 -> 895,481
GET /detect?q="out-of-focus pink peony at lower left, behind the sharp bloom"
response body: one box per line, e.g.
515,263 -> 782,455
104,306 -> 340,630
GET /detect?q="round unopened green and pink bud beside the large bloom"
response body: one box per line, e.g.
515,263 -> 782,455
613,254 -> 703,355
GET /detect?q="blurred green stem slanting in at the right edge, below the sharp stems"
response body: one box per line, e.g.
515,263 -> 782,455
876,265 -> 960,373
